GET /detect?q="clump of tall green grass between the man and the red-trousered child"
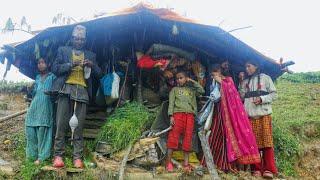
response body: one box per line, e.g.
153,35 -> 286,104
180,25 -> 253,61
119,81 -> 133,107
97,102 -> 154,151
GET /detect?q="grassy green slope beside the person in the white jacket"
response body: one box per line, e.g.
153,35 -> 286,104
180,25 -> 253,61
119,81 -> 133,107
273,73 -> 320,176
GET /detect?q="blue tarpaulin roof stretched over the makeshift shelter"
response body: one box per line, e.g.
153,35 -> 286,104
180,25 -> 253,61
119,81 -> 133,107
3,4 -> 283,78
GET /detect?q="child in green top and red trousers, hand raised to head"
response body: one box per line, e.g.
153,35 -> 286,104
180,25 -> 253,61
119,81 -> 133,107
166,71 -> 204,172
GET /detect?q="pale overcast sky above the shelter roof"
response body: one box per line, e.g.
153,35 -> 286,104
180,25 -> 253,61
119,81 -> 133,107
0,0 -> 320,80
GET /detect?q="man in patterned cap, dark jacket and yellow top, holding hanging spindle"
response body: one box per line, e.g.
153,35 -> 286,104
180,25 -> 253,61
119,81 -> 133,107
52,25 -> 102,168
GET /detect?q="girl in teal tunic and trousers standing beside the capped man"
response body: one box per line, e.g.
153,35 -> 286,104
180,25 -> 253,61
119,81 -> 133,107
25,58 -> 55,165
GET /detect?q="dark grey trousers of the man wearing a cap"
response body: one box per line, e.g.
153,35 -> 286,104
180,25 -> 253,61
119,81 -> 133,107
54,95 -> 87,160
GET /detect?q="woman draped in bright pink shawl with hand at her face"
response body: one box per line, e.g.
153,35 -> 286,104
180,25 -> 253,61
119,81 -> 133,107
202,65 -> 261,171
